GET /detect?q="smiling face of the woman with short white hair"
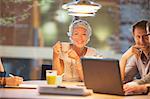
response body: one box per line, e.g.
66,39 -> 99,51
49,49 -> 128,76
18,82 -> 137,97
71,27 -> 89,48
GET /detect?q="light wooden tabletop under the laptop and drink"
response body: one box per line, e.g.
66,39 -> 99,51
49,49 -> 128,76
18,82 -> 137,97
0,80 -> 150,99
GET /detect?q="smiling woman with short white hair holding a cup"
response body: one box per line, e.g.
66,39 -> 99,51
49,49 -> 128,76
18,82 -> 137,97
53,20 -> 101,81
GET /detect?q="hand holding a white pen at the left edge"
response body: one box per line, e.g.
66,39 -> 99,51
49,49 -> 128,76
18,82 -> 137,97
5,76 -> 23,86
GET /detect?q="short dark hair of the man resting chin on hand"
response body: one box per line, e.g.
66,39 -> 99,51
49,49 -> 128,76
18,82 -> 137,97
132,20 -> 148,34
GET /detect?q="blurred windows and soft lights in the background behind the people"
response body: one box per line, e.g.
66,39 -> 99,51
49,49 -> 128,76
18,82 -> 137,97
0,0 -> 150,80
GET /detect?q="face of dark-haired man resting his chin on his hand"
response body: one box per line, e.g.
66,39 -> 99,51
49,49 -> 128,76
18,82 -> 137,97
133,28 -> 150,48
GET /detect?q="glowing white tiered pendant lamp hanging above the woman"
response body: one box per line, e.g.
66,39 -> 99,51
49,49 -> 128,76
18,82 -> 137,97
62,0 -> 101,16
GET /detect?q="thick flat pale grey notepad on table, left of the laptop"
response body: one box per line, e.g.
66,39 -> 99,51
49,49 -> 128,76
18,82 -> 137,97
38,85 -> 93,96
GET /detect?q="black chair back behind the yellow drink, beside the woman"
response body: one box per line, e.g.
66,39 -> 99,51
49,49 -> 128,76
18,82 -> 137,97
41,64 -> 52,80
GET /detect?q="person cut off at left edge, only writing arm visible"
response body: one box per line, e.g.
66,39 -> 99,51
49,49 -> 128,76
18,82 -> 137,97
0,59 -> 23,86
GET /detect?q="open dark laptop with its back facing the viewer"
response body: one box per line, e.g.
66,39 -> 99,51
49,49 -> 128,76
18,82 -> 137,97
81,58 -> 138,95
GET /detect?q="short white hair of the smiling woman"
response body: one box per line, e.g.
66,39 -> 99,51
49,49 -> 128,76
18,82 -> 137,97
67,19 -> 92,37
